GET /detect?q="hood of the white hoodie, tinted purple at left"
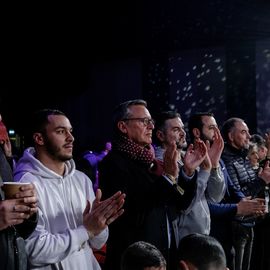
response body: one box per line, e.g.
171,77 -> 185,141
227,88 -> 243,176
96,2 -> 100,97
14,147 -> 75,180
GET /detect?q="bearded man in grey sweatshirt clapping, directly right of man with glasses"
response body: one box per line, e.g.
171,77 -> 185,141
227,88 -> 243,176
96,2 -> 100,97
156,111 -> 225,244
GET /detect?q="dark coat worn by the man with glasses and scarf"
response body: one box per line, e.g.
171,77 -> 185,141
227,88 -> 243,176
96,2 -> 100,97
99,150 -> 197,269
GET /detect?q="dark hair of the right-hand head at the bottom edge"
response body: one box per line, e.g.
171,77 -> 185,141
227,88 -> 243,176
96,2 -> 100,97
178,233 -> 226,270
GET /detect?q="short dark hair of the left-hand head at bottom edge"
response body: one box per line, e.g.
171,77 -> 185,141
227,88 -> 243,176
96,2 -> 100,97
121,241 -> 166,270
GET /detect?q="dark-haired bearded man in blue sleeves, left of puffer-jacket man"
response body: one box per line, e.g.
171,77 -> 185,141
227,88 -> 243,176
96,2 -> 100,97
189,112 -> 264,270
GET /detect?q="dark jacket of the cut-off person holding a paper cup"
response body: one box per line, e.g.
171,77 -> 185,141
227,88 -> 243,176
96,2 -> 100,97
0,147 -> 37,270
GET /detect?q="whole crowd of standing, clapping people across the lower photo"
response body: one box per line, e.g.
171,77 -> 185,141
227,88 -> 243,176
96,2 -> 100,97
0,99 -> 270,270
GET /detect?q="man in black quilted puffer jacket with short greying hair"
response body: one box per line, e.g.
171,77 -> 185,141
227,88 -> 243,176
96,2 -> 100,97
222,117 -> 270,270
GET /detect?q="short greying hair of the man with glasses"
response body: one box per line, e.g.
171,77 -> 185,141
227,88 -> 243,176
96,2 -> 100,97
113,99 -> 147,135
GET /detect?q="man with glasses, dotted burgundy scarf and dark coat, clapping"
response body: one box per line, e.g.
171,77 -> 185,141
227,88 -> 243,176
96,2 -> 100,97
99,100 -> 206,270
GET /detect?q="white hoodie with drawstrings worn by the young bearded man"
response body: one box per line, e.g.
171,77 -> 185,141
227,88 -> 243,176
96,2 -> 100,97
14,147 -> 108,270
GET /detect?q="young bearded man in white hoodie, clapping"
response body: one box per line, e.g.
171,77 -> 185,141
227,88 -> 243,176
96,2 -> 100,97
15,109 -> 125,270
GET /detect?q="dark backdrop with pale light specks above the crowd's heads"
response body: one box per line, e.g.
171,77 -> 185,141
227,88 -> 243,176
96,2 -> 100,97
0,0 -> 270,154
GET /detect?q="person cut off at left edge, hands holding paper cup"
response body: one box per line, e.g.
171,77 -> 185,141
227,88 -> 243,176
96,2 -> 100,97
0,115 -> 37,270
